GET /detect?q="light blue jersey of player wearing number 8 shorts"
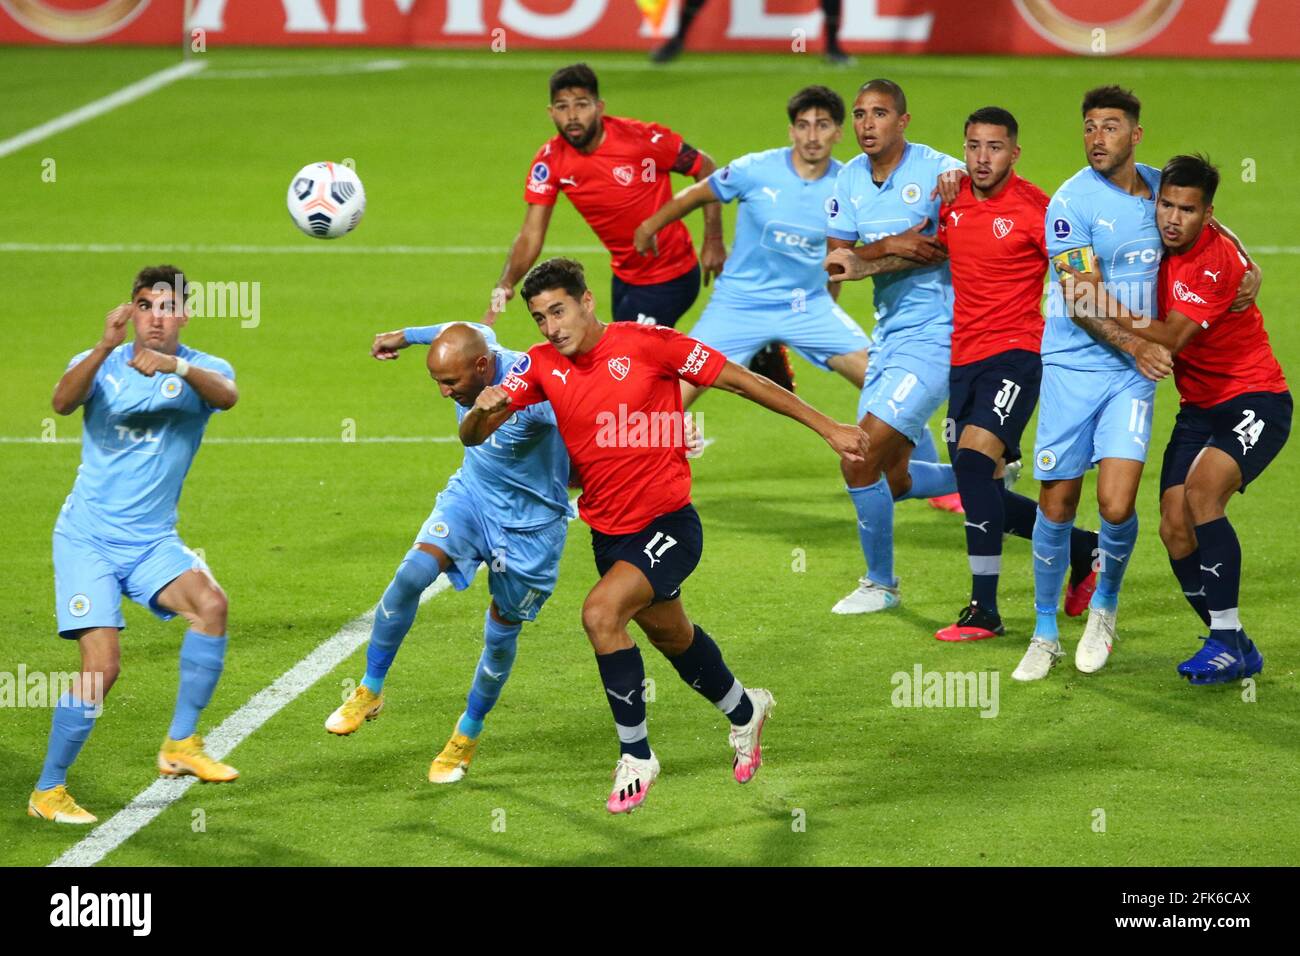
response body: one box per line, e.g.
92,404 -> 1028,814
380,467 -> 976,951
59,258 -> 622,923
826,143 -> 963,365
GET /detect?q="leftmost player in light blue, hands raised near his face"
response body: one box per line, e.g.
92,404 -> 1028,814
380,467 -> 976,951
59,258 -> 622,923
27,265 -> 239,823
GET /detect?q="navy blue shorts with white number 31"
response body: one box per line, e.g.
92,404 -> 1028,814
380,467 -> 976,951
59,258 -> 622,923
948,349 -> 1043,462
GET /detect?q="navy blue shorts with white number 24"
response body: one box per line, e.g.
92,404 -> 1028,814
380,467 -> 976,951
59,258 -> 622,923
1160,392 -> 1292,494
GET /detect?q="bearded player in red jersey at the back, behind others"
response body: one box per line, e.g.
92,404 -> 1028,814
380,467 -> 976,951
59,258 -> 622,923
484,64 -> 727,325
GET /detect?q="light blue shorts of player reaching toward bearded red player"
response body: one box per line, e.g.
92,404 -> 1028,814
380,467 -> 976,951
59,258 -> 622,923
690,293 -> 870,368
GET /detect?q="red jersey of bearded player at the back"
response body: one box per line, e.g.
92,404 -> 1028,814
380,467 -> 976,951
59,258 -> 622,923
524,116 -> 699,285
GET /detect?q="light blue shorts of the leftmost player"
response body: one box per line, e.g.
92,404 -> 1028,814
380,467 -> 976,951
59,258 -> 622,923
55,518 -> 208,637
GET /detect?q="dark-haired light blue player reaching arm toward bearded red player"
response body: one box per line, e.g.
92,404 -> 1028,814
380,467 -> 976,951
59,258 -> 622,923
632,86 -> 870,408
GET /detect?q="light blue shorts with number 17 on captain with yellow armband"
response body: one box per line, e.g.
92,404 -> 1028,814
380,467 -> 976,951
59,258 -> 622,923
1034,364 -> 1156,481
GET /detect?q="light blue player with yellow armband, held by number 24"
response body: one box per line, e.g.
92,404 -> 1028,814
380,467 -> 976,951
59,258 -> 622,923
1011,86 -> 1258,680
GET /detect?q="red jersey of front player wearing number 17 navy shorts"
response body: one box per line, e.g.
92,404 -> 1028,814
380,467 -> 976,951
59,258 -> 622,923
502,323 -> 727,535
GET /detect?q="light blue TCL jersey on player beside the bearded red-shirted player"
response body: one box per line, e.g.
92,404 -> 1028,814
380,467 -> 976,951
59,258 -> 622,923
707,147 -> 844,304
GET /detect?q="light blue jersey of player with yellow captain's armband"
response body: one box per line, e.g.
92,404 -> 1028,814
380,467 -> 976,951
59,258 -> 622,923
1043,163 -> 1161,371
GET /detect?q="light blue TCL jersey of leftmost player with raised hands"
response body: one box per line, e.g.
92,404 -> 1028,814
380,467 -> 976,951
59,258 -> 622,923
60,343 -> 234,544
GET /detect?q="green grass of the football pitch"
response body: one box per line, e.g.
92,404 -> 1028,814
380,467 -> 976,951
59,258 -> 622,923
0,49 -> 1300,865
